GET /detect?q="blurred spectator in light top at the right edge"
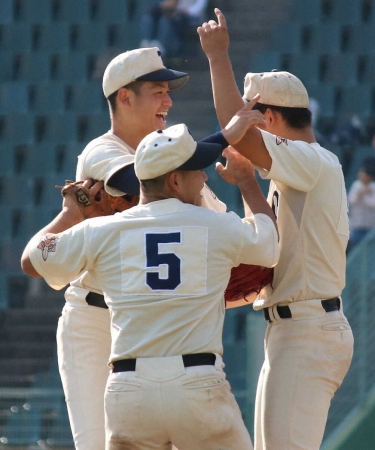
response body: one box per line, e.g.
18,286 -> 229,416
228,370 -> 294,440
348,156 -> 375,252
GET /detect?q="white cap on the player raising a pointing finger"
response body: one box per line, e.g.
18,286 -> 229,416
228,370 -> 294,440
244,69 -> 309,108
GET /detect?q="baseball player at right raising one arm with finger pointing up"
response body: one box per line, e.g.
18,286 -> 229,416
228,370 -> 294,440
198,9 -> 353,450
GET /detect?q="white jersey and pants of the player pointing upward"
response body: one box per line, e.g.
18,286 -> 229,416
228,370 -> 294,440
254,131 -> 353,450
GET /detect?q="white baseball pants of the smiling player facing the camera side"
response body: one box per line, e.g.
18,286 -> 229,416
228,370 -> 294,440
57,303 -> 111,450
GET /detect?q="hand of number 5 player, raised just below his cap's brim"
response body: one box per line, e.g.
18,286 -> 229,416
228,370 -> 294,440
216,147 -> 255,185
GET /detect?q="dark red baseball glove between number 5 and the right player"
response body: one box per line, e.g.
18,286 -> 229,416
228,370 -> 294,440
225,264 -> 273,308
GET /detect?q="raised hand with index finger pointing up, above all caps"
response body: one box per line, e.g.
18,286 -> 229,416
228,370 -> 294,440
197,8 -> 229,59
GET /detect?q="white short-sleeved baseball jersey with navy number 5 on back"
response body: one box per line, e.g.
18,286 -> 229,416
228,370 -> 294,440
30,199 -> 279,361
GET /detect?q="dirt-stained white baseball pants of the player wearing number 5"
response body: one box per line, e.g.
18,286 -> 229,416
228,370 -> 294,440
105,356 -> 253,450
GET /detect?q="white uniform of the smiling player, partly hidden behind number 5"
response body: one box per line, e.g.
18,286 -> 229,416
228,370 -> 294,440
57,131 -> 226,450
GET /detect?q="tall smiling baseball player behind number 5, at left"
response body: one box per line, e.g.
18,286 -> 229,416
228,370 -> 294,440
57,48 -> 191,450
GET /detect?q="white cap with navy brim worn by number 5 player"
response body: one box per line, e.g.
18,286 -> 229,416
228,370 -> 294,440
134,123 -> 222,180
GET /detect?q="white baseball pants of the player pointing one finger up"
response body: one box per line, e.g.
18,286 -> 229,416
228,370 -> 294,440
254,300 -> 353,450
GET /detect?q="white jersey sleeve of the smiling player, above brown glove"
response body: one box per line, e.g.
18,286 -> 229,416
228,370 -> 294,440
76,140 -> 134,196
